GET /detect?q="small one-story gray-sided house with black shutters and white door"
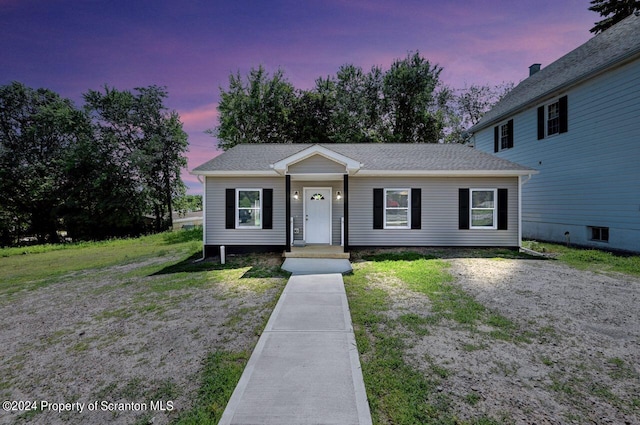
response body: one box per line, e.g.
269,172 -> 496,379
192,144 -> 536,256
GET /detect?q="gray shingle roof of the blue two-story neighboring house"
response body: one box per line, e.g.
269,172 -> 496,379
469,14 -> 640,133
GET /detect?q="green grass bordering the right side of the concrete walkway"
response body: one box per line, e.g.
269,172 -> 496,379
344,252 -> 519,425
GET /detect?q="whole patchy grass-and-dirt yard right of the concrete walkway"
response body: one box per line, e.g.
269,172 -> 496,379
345,250 -> 640,424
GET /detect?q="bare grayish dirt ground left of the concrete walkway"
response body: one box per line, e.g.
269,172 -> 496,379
0,253 -> 286,425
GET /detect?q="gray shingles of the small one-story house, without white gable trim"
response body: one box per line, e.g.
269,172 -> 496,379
193,143 -> 534,174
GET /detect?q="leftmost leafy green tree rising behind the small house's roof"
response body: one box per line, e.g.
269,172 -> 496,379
208,66 -> 296,150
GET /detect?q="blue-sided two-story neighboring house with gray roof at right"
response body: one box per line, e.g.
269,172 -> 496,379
470,15 -> 640,251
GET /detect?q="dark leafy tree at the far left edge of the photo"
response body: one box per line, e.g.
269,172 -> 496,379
0,82 -> 89,243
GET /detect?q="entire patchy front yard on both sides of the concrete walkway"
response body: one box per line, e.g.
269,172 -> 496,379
0,232 -> 640,424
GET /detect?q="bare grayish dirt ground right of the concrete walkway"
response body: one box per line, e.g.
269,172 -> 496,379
378,255 -> 640,424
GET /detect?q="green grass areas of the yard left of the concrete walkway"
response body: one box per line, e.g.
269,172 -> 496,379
0,228 -> 289,424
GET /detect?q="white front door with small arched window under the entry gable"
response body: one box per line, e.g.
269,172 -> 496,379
304,187 -> 331,244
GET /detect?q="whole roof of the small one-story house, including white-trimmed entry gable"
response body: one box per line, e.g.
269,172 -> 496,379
192,143 -> 537,176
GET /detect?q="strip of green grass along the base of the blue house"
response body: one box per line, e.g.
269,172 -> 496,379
523,241 -> 640,276
